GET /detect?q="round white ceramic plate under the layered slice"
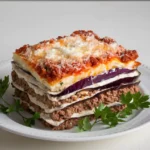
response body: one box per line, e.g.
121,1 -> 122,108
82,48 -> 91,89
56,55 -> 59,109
0,60 -> 150,142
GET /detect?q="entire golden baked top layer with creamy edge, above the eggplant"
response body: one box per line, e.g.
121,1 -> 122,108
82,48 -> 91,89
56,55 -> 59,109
13,30 -> 140,91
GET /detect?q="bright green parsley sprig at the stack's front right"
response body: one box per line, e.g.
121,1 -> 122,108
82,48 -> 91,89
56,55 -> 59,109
78,92 -> 150,131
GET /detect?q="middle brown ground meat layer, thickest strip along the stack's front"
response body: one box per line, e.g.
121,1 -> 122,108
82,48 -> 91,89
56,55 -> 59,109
15,85 -> 139,121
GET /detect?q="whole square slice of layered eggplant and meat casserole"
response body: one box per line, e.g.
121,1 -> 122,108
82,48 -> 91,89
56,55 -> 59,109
12,30 -> 140,130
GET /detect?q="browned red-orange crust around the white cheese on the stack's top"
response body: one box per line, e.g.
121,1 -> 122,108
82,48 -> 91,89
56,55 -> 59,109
14,30 -> 140,85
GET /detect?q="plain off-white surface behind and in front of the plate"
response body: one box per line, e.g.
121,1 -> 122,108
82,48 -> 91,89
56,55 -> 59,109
0,2 -> 150,150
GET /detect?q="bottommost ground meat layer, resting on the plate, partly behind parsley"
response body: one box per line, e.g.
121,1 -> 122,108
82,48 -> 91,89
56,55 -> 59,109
21,98 -> 125,130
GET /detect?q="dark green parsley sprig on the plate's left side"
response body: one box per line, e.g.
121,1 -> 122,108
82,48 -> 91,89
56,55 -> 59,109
0,76 -> 40,127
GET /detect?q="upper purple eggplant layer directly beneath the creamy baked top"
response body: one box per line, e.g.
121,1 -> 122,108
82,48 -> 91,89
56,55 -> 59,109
12,62 -> 140,97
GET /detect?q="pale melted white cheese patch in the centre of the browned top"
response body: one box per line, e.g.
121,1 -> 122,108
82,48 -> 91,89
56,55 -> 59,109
32,35 -> 118,61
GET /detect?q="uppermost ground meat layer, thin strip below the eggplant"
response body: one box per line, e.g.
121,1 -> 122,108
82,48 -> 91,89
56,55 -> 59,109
12,71 -> 139,112
